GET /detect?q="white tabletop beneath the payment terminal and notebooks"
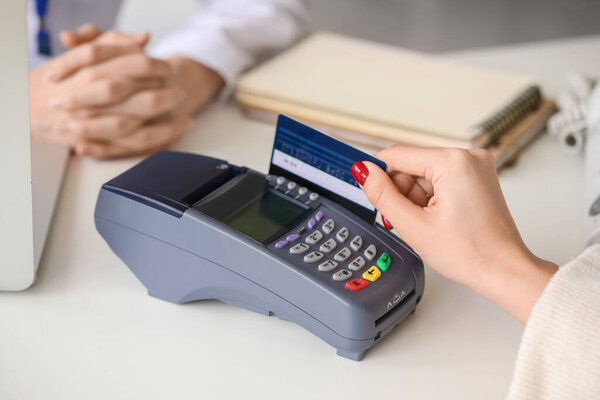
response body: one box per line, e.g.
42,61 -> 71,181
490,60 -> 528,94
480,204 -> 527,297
0,37 -> 600,400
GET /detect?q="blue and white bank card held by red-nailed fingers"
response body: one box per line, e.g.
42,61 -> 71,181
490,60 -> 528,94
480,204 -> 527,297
269,115 -> 387,224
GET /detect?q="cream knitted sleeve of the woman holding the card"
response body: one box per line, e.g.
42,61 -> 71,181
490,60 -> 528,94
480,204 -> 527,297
508,245 -> 600,399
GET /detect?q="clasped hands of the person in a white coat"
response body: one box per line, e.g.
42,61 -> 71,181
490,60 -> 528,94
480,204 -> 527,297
30,25 -> 223,158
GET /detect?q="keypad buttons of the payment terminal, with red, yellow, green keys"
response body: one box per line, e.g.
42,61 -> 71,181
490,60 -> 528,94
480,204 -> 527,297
267,176 -> 392,292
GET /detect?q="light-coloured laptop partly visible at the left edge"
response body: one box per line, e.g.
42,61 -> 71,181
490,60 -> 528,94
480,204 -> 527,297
0,0 -> 69,290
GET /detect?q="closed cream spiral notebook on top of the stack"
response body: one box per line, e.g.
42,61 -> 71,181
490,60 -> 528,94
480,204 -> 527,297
236,33 -> 542,148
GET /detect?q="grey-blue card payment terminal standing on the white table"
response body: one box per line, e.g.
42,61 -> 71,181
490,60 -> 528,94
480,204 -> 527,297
95,151 -> 424,360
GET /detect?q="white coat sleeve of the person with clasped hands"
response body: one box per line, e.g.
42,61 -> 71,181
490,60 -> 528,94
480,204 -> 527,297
150,0 -> 309,94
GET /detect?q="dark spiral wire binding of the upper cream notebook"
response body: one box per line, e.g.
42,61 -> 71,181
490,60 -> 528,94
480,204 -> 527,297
479,86 -> 542,144
